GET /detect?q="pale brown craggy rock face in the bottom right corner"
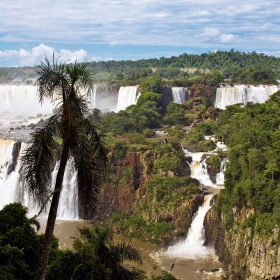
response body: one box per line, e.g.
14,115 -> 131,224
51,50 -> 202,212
204,202 -> 280,280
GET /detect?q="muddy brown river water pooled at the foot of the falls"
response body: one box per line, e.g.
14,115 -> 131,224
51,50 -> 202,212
39,219 -> 223,280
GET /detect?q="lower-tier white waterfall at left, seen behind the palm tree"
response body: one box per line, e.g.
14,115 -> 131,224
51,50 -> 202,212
0,139 -> 79,220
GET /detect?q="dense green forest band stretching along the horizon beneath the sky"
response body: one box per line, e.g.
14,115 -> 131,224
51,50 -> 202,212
0,49 -> 280,88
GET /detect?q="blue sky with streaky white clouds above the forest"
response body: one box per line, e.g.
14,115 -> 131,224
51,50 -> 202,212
0,0 -> 280,67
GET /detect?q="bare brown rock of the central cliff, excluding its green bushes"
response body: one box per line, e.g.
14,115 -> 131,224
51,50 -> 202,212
93,151 -> 204,243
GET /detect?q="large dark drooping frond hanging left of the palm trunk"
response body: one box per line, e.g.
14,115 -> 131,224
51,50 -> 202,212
20,115 -> 59,204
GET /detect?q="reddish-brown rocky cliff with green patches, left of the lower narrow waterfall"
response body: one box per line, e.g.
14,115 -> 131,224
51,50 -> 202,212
94,150 -> 204,244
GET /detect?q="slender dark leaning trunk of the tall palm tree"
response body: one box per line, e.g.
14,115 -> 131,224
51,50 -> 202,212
35,141 -> 70,280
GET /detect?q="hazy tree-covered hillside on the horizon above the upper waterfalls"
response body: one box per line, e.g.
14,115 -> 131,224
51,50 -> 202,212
0,50 -> 280,86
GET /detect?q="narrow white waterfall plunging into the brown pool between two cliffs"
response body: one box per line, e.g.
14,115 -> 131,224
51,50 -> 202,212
166,194 -> 214,259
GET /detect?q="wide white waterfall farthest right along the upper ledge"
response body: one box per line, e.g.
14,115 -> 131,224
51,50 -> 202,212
215,85 -> 280,109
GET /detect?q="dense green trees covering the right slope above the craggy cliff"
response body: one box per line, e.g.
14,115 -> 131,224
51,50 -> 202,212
215,92 -> 280,234
